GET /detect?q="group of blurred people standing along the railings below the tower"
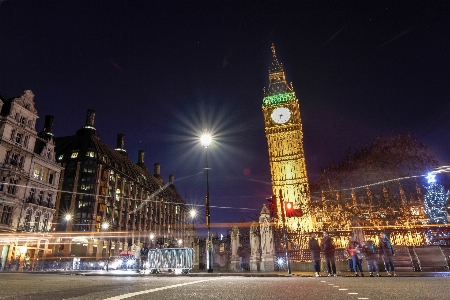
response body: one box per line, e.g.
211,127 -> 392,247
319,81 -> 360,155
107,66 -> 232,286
309,231 -> 397,277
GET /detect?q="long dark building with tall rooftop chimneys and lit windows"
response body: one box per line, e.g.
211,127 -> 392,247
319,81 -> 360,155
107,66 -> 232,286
53,110 -> 187,259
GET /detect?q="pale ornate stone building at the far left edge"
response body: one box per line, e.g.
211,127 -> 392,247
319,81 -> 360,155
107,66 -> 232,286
0,90 -> 61,269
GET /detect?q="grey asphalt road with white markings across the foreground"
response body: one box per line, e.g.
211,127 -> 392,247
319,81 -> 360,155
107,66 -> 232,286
0,273 -> 450,300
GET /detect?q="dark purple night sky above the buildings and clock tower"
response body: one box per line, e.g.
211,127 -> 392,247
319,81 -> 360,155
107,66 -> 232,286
0,0 -> 450,233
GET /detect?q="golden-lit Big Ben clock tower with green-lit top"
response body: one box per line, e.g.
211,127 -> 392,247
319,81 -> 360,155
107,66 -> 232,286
262,44 -> 313,231
